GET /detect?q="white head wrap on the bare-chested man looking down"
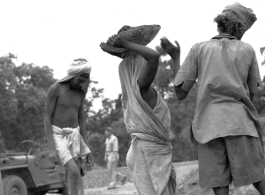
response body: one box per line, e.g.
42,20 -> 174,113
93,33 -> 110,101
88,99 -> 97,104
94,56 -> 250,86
58,58 -> 91,83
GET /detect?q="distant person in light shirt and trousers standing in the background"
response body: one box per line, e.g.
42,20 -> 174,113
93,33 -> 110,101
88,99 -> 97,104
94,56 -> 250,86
105,127 -> 119,187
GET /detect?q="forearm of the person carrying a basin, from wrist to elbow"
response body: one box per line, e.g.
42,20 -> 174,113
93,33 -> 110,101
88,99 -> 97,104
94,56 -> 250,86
121,40 -> 159,61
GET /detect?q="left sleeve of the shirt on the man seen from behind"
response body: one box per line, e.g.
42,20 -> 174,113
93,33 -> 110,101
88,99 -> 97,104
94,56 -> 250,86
173,44 -> 198,92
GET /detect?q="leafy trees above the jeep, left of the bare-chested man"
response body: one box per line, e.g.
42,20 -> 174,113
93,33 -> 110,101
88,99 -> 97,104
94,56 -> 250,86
0,54 -> 55,150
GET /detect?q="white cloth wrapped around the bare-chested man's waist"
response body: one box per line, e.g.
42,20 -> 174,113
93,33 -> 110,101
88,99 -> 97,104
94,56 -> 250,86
52,125 -> 91,165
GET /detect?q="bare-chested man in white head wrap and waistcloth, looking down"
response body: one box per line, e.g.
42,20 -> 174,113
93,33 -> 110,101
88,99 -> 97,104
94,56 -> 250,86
44,59 -> 91,195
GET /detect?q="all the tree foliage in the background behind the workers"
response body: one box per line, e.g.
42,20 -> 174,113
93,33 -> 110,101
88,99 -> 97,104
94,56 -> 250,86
0,47 -> 265,166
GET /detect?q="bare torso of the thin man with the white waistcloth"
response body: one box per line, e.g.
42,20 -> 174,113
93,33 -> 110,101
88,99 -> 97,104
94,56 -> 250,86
51,83 -> 83,128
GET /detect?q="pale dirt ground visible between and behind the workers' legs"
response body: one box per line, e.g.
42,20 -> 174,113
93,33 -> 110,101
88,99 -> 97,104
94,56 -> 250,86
84,161 -> 259,195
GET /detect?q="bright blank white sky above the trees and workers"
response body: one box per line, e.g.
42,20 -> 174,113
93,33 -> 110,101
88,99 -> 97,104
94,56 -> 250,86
0,0 -> 265,108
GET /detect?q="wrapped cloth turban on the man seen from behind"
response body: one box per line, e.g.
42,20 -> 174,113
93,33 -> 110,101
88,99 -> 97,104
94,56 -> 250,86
223,2 -> 257,30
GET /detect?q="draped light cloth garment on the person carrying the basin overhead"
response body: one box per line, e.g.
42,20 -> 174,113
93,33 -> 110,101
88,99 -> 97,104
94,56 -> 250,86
119,55 -> 176,195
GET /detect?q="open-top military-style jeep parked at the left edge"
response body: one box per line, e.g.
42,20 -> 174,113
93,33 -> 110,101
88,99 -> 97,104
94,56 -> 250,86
0,140 -> 68,195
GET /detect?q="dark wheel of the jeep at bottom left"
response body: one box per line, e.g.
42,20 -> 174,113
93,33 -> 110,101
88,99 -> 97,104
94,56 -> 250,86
3,175 -> 28,195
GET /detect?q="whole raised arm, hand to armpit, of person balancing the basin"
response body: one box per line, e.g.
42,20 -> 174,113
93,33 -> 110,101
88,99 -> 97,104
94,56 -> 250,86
108,35 -> 160,90
